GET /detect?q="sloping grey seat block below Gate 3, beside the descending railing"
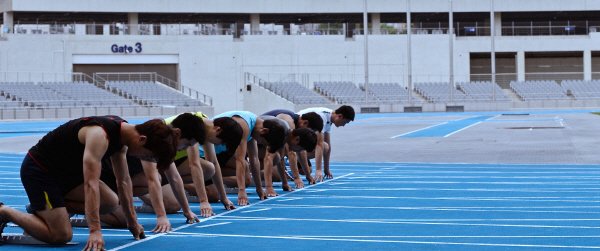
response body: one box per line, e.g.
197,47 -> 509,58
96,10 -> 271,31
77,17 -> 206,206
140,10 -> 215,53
105,81 -> 206,106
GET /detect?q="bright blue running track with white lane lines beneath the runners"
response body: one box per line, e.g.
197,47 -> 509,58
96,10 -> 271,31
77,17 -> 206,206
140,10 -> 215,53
0,115 -> 600,251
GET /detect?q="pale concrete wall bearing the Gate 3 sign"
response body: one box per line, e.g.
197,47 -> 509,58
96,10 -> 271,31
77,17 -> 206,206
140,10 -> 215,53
0,33 -> 600,113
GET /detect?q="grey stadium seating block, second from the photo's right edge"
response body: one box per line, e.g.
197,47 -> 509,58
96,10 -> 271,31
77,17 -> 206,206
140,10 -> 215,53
510,80 -> 569,101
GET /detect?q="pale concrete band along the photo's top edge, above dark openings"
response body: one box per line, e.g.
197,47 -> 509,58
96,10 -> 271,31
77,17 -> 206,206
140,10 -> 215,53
0,0 -> 600,14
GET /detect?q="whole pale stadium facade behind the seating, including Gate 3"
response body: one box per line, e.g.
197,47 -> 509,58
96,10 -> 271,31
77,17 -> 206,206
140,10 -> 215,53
0,0 -> 600,113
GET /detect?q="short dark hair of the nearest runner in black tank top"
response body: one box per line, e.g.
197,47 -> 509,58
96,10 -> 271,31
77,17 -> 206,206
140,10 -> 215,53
135,119 -> 178,169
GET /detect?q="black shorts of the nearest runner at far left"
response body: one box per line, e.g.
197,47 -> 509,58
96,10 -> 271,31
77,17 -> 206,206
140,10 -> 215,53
21,154 -> 65,211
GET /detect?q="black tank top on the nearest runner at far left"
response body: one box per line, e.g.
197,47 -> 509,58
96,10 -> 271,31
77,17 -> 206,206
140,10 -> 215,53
29,115 -> 127,182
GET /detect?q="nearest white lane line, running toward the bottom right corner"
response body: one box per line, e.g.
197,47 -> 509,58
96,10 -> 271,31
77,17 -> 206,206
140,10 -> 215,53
152,234 -> 600,249
